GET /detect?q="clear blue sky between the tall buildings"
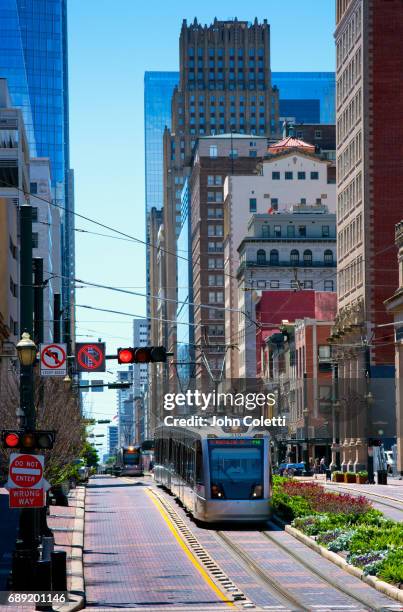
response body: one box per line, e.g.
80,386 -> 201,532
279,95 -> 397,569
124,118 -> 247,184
68,0 -> 335,440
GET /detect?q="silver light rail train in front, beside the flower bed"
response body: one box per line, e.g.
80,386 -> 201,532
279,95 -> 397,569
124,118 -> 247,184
154,426 -> 271,522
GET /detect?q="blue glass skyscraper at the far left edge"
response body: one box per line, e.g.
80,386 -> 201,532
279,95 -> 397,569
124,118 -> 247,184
0,0 -> 74,340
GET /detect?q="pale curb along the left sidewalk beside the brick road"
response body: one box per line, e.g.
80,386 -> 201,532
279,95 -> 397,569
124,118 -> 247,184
53,487 -> 86,612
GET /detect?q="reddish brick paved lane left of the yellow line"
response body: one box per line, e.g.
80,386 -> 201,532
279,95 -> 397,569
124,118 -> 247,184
84,477 -> 227,610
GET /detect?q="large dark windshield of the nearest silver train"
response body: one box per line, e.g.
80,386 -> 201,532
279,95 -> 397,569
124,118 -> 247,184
209,440 -> 263,499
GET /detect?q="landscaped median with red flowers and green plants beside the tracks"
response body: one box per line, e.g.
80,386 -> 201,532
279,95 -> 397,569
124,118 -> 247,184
273,476 -> 403,601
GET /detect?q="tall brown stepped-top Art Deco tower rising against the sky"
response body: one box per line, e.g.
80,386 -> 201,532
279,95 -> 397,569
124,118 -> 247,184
163,19 -> 278,392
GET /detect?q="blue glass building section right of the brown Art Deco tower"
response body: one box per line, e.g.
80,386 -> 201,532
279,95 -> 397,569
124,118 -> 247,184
271,72 -> 336,124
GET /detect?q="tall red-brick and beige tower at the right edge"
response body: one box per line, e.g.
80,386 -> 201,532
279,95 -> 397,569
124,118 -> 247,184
333,0 -> 403,470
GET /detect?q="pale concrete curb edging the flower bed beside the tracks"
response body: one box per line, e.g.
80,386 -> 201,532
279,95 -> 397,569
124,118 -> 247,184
285,525 -> 403,603
